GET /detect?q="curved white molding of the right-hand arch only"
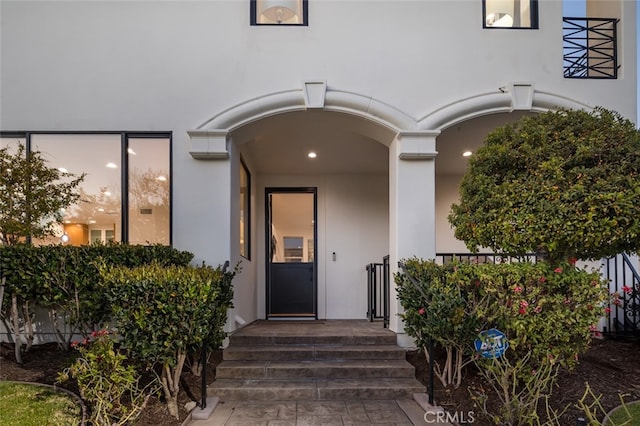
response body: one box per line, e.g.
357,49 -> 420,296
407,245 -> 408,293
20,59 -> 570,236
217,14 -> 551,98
418,83 -> 592,130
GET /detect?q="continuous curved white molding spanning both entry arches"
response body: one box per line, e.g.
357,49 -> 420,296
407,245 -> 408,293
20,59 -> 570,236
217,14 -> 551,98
187,80 -> 591,159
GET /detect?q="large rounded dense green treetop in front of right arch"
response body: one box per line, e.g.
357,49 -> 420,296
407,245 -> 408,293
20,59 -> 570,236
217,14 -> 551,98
449,108 -> 640,262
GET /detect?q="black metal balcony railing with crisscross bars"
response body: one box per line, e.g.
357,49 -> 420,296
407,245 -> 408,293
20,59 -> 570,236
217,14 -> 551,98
562,18 -> 619,79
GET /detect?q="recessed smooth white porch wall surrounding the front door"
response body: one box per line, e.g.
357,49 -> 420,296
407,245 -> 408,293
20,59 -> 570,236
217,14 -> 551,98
256,175 -> 389,319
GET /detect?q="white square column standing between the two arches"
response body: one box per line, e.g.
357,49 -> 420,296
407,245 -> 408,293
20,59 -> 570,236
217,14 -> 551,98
389,131 -> 440,346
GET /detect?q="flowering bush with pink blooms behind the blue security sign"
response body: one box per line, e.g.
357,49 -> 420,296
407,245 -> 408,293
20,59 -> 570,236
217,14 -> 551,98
396,258 -> 609,424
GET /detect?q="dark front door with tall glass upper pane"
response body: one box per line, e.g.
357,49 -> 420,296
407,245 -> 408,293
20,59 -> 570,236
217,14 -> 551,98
265,188 -> 317,319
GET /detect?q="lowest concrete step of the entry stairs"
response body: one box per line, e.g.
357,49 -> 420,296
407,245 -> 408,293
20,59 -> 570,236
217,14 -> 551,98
207,378 -> 425,401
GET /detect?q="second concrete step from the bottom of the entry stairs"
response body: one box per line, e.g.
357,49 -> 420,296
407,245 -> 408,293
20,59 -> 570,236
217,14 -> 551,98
216,359 -> 415,379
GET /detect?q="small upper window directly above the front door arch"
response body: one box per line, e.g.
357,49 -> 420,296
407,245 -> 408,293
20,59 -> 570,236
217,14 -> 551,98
250,0 -> 308,26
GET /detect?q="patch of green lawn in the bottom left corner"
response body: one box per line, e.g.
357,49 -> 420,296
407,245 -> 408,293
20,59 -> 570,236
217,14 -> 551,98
0,381 -> 82,426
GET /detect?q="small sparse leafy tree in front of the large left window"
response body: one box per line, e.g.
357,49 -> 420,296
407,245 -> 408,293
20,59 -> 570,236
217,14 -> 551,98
0,144 -> 85,245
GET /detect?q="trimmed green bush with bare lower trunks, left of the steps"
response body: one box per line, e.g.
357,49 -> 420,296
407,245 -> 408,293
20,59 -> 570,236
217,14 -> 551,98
101,264 -> 236,417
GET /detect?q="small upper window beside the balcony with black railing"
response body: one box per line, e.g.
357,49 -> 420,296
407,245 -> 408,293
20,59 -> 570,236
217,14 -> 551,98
482,0 -> 538,29
